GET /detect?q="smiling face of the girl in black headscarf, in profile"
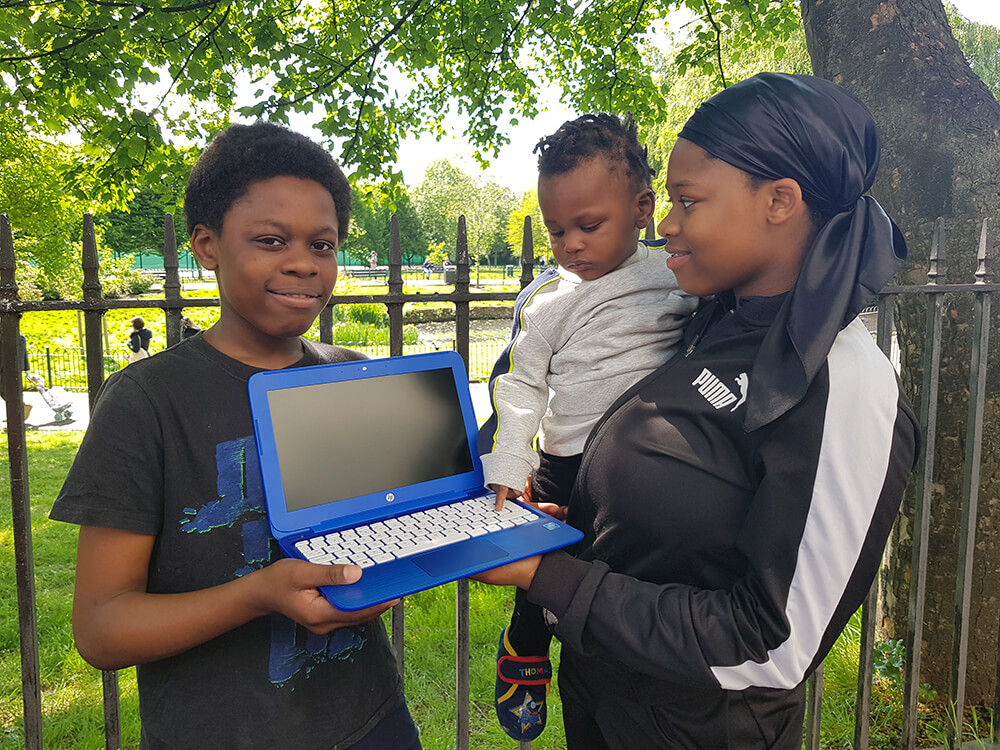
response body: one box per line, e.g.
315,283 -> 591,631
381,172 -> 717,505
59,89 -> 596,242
657,138 -> 803,297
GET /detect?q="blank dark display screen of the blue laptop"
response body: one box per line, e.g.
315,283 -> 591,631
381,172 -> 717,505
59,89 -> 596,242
267,368 -> 474,512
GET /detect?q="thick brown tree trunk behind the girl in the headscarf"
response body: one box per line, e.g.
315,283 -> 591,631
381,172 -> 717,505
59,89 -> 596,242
802,0 -> 1000,706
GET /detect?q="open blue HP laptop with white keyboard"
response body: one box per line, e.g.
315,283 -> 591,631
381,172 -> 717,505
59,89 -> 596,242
249,352 -> 583,610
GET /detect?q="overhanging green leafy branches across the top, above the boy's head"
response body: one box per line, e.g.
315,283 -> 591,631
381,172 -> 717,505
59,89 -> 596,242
0,0 -> 798,204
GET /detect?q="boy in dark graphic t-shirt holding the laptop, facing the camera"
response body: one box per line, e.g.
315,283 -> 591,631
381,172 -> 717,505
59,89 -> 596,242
51,123 -> 420,750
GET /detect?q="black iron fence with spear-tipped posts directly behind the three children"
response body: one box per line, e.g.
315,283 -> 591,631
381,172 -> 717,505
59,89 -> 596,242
0,214 -> 1000,750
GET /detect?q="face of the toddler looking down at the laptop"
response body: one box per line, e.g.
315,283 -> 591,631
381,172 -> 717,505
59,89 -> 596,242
538,157 -> 655,281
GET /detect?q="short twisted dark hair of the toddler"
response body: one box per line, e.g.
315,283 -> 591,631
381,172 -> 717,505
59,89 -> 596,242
532,112 -> 653,192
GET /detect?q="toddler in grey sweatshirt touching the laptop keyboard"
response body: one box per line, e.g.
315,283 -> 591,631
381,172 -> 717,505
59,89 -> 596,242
479,114 -> 697,740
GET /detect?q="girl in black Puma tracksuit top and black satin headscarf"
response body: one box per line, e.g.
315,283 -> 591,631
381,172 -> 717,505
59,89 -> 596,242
476,73 -> 919,750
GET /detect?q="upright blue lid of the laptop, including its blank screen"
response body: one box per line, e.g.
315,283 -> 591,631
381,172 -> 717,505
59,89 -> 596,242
248,352 -> 483,538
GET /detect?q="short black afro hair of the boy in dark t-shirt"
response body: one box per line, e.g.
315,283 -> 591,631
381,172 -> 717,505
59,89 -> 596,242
184,122 -> 351,242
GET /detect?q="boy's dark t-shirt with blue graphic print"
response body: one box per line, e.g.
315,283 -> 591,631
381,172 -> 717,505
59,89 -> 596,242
50,336 -> 401,750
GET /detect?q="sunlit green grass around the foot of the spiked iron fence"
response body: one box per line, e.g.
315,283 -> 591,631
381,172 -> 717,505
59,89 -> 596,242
9,432 -> 992,750
